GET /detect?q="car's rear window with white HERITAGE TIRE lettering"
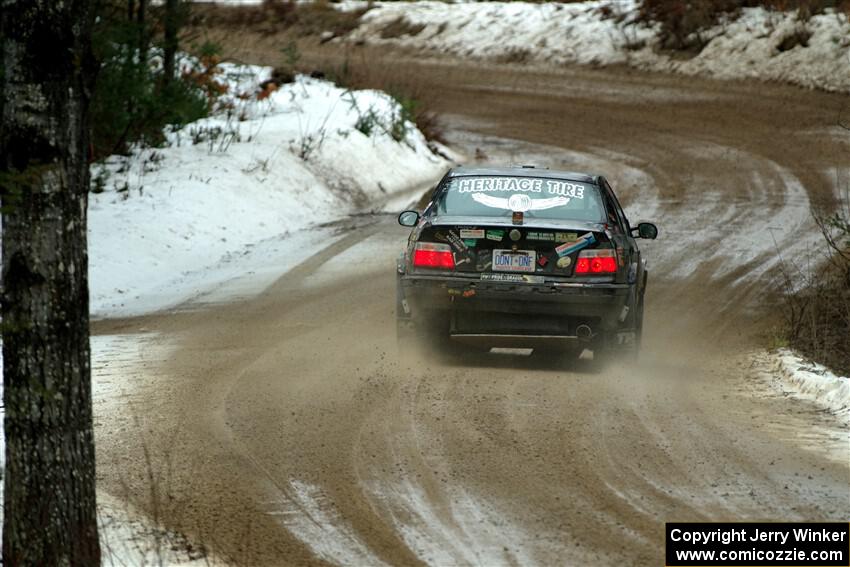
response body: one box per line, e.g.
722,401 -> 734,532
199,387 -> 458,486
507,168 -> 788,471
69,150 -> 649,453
437,176 -> 605,222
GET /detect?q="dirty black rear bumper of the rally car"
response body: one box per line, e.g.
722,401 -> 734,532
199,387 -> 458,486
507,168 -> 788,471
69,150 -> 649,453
398,274 -> 636,336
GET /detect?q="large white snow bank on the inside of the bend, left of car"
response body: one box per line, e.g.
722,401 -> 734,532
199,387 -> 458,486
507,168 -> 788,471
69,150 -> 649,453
89,64 -> 448,317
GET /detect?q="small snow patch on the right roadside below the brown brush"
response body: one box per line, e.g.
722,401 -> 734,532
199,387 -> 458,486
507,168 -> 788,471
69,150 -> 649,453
757,348 -> 850,424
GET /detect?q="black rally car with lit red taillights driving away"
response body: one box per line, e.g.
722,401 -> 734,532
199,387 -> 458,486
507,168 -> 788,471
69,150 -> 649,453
396,166 -> 658,358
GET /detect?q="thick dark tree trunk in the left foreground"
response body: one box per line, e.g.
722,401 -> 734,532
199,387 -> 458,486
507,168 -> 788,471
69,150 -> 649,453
0,0 -> 100,566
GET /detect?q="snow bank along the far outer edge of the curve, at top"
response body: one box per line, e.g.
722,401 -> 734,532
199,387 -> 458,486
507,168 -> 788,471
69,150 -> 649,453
342,0 -> 850,92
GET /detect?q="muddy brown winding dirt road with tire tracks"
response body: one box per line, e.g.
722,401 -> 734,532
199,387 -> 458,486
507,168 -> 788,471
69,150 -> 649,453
96,56 -> 850,565
